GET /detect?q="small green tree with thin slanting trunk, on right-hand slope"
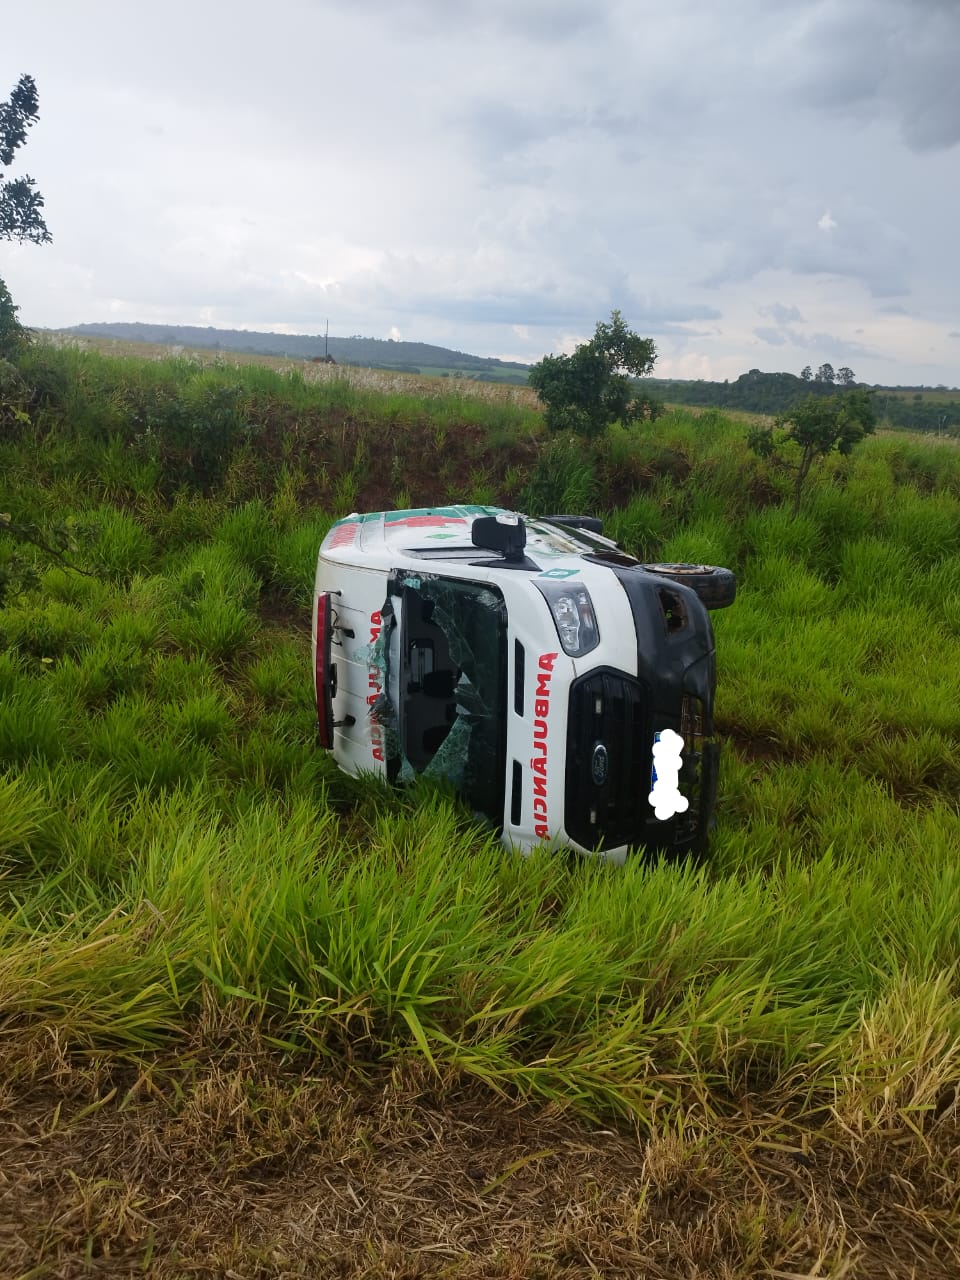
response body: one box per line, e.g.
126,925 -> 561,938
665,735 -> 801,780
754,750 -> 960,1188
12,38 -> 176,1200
746,389 -> 877,515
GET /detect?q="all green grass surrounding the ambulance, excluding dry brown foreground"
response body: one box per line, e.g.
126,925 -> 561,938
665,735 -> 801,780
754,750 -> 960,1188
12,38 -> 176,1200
0,352 -> 960,1125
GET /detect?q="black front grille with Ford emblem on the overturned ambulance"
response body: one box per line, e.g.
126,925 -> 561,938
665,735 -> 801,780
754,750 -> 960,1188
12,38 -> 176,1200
564,669 -> 653,849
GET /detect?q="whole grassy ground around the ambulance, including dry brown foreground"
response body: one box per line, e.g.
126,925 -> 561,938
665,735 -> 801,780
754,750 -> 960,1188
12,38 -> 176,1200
0,337 -> 960,1277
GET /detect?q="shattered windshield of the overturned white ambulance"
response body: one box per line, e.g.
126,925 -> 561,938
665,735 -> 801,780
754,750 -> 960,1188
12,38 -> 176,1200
390,573 -> 507,828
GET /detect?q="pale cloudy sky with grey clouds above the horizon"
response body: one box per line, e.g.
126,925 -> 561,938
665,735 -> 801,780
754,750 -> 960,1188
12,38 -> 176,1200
0,0 -> 960,387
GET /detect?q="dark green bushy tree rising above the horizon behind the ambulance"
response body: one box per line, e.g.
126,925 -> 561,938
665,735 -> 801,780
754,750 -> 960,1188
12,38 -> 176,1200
529,311 -> 660,435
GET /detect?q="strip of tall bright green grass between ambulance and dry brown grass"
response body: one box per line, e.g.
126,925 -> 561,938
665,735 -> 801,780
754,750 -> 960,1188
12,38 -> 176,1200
0,781 -> 960,1119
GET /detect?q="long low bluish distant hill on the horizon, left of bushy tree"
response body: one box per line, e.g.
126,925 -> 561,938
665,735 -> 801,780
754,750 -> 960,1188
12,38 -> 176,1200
60,324 -> 529,385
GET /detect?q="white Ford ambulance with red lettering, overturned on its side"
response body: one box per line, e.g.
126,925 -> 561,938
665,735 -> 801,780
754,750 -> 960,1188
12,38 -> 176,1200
314,506 -> 736,861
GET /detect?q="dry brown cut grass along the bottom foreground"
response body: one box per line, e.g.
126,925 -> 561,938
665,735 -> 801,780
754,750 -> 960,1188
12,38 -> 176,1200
0,1029 -> 960,1280
